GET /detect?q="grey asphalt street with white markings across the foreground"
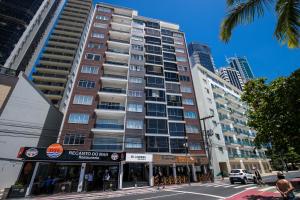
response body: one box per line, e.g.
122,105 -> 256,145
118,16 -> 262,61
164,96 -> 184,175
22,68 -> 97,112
21,171 -> 300,200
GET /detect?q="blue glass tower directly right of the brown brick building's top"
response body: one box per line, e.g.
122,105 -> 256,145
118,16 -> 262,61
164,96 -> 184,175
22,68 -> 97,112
188,42 -> 215,72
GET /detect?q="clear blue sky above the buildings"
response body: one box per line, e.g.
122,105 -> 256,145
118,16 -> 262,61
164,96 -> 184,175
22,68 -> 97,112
96,0 -> 300,80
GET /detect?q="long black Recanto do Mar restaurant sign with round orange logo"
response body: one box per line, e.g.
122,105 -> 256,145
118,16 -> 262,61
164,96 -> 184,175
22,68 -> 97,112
18,145 -> 125,162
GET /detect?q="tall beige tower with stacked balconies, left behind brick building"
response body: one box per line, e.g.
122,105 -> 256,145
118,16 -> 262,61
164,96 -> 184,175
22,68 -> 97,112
26,0 -> 92,106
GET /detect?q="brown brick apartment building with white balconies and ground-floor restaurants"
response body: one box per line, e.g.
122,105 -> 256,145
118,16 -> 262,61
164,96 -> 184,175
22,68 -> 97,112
16,4 -> 208,194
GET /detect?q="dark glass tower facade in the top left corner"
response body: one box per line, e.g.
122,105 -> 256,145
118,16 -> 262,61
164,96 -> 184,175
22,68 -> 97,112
0,0 -> 43,71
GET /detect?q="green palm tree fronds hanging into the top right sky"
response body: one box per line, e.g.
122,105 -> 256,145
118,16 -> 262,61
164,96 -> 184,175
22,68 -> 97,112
220,0 -> 300,48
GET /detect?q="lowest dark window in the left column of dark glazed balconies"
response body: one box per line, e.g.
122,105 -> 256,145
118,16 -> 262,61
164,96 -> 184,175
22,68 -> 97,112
146,136 -> 169,152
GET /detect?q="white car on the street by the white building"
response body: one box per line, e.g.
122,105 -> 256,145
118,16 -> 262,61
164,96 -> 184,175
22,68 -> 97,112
229,169 -> 257,184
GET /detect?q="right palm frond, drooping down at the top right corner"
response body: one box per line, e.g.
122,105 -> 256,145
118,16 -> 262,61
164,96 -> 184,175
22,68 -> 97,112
274,0 -> 300,48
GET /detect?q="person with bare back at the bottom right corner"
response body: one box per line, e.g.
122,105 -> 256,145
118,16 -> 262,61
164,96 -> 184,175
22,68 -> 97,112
276,172 -> 296,200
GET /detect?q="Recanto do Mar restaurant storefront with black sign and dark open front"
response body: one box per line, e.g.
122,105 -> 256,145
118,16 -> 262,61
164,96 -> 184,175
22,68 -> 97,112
13,144 -> 125,195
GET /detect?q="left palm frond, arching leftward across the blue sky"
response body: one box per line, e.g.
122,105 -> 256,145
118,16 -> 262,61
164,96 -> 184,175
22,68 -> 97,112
220,0 -> 273,42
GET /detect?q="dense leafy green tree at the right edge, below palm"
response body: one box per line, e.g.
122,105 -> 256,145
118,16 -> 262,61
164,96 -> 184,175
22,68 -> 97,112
242,69 -> 300,155
